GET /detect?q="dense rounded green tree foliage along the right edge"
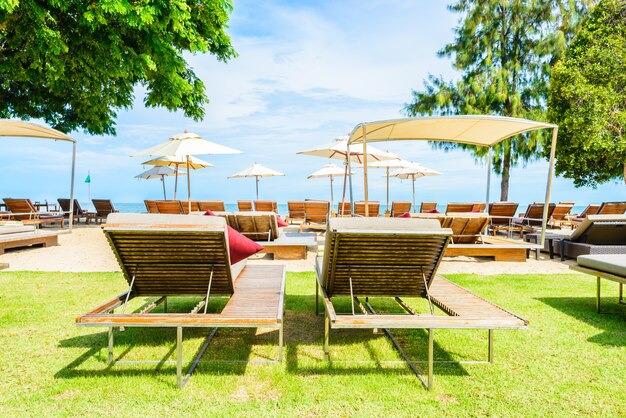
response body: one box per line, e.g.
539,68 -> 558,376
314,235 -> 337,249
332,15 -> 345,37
548,0 -> 626,187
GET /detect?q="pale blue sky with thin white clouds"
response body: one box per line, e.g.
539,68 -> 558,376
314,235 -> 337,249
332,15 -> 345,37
0,0 -> 626,204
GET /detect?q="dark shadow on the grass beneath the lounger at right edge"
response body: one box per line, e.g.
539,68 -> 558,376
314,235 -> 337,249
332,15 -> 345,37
537,297 -> 626,347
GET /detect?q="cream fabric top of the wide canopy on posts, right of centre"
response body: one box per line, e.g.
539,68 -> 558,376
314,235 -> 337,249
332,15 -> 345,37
349,115 -> 557,148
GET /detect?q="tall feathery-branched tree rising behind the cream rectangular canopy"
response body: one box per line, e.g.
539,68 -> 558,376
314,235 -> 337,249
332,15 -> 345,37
405,0 -> 589,200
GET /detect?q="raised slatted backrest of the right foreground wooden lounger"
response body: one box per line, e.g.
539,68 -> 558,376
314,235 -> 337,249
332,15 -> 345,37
321,218 -> 452,297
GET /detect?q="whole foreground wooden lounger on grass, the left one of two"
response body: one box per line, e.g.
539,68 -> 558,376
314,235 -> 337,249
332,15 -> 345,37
76,213 -> 285,387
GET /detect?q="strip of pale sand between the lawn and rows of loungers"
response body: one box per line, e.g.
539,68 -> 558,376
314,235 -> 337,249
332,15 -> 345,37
0,225 -> 574,275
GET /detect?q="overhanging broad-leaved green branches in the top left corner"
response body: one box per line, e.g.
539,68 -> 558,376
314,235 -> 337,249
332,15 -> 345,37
0,0 -> 235,134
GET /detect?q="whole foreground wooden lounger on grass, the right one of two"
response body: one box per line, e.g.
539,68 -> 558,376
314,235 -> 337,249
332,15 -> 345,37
316,218 -> 528,390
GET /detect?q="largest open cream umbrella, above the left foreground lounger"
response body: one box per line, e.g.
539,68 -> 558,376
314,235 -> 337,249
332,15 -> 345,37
134,131 -> 241,212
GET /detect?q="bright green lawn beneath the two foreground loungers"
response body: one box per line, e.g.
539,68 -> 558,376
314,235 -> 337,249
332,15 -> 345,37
0,272 -> 626,416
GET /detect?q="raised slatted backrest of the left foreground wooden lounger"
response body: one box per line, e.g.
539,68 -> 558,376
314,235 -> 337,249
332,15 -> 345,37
103,213 -> 233,296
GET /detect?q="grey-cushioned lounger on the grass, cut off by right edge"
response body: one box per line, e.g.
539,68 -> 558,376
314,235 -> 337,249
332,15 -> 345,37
570,254 -> 626,313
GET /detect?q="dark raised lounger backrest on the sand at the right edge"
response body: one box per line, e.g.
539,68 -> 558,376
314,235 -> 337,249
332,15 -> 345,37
567,215 -> 626,245
